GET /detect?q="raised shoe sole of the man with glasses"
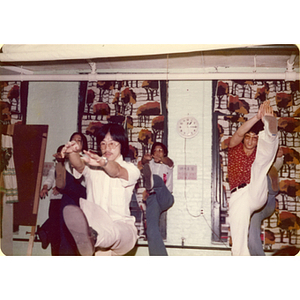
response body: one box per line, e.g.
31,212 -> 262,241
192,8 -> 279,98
63,205 -> 95,256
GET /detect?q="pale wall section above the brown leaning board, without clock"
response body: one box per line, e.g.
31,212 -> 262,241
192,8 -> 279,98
27,82 -> 79,162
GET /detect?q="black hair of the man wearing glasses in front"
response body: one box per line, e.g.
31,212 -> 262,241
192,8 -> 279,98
96,123 -> 129,158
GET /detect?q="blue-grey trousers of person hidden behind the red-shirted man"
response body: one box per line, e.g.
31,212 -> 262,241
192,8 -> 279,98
248,176 -> 278,256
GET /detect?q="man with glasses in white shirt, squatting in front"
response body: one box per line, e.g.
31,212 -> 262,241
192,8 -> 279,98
61,124 -> 140,255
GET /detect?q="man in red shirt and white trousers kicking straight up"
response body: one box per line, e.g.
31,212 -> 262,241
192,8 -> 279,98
228,101 -> 278,255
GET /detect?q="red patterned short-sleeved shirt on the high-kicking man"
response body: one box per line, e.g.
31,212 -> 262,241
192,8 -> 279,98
227,143 -> 256,190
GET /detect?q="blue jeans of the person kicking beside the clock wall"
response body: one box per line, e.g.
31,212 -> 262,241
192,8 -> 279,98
146,175 -> 174,256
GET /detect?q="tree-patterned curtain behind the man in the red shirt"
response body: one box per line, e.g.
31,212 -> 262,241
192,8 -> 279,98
213,81 -> 300,249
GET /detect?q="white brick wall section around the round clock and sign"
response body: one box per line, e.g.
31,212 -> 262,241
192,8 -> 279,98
167,81 -> 212,246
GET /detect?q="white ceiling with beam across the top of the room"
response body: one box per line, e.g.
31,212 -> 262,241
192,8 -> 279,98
0,44 -> 299,81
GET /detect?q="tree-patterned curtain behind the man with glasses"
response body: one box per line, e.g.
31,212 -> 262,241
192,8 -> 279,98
78,81 -> 167,238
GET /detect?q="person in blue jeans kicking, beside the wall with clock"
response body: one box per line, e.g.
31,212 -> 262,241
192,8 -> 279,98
142,142 -> 174,256
